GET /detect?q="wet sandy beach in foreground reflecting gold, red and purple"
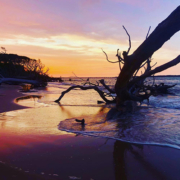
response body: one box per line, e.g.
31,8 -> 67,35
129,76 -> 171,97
0,85 -> 180,180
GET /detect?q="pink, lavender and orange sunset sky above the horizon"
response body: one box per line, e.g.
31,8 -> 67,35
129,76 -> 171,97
0,0 -> 180,77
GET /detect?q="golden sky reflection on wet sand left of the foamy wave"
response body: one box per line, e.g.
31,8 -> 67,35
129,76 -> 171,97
0,106 -> 105,135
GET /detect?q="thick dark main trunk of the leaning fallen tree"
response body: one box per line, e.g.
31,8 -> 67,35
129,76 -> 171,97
115,6 -> 180,104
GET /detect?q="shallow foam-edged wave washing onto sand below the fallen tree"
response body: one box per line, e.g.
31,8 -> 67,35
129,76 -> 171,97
58,108 -> 180,149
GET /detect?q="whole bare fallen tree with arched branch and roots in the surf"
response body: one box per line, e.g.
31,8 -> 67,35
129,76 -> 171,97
55,6 -> 180,107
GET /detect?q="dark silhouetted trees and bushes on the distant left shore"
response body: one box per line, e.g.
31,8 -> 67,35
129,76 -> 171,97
0,50 -> 49,85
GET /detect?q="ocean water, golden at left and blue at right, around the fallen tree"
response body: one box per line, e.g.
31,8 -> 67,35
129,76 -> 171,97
15,77 -> 180,149
